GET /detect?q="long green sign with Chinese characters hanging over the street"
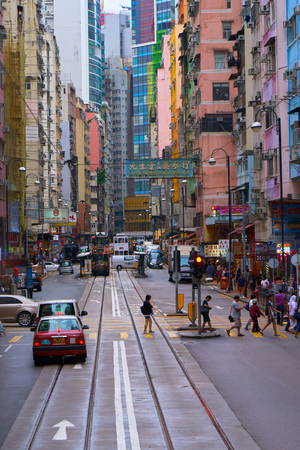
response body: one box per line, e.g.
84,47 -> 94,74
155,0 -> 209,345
126,159 -> 193,178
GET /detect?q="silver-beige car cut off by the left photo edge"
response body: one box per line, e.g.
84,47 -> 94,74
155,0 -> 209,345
0,294 -> 38,327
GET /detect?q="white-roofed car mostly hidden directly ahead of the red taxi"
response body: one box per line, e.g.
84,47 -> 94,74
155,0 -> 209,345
34,299 -> 87,327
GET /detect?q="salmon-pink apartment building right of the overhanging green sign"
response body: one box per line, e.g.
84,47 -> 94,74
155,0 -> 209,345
190,0 -> 241,244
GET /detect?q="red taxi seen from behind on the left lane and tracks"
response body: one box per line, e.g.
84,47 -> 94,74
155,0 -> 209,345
31,316 -> 89,365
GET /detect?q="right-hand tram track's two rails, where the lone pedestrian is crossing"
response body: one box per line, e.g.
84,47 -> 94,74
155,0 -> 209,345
125,273 -> 235,450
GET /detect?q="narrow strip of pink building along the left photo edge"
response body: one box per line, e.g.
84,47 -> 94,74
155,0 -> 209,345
0,2 -> 6,260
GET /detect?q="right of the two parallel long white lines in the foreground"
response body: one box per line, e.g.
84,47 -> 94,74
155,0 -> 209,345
119,341 -> 141,450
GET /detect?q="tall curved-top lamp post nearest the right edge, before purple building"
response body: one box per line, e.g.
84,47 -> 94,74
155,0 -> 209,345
251,106 -> 285,281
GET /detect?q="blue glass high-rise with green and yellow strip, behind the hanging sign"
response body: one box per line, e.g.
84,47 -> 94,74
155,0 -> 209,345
131,0 -> 175,195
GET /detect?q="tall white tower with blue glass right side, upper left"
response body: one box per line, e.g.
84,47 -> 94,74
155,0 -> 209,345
45,0 -> 102,109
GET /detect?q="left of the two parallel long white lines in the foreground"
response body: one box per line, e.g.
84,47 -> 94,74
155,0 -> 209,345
114,341 -> 126,450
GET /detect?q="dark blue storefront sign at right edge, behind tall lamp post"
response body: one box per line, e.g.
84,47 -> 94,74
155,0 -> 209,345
272,204 -> 300,234
